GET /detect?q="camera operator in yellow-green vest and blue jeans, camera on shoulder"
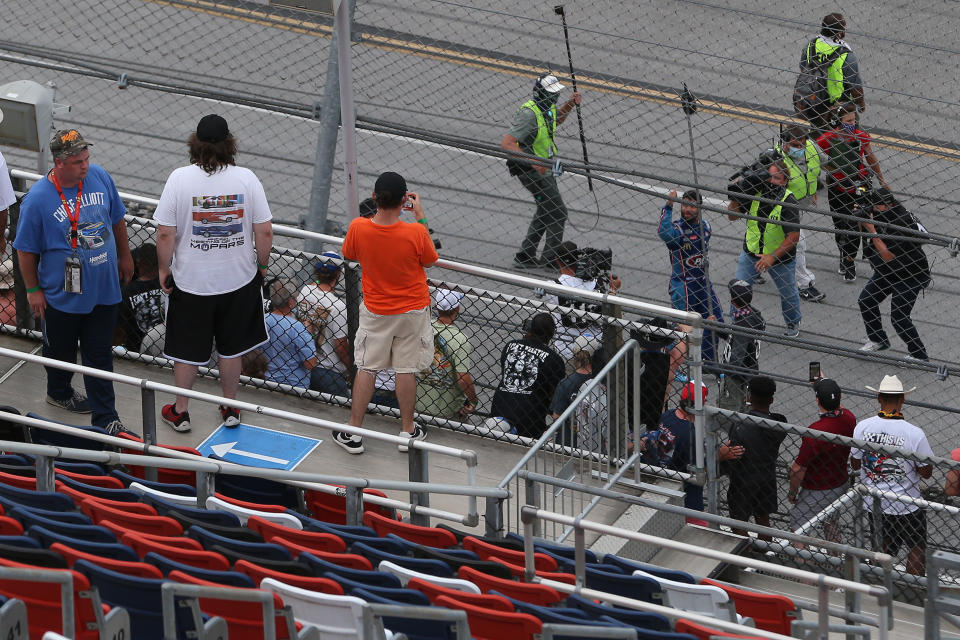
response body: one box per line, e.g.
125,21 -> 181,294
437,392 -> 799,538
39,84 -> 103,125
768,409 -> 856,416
727,154 -> 802,338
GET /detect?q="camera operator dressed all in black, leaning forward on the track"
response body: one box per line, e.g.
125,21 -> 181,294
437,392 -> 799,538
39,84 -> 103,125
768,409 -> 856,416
859,187 -> 930,360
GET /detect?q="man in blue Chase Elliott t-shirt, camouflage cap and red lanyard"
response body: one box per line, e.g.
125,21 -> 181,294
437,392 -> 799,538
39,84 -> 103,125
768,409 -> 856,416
13,129 -> 133,435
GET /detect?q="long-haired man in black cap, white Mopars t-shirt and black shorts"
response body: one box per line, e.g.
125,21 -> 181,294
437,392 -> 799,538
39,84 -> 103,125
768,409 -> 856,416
153,114 -> 273,431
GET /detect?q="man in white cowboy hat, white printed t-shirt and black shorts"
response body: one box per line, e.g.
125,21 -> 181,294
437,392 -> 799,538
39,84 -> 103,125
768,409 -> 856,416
850,376 -> 933,575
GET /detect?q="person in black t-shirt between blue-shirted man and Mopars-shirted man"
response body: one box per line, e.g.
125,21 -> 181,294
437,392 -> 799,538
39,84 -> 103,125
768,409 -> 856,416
114,242 -> 165,351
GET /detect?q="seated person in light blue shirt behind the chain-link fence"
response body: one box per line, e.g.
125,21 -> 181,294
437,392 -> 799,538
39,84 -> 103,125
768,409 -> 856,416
263,280 -> 317,389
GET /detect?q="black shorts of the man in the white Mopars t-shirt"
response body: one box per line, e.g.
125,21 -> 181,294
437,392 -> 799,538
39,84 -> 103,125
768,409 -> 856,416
163,272 -> 270,365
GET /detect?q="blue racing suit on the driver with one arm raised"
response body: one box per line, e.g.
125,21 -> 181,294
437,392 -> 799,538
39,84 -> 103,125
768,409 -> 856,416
657,205 -> 723,362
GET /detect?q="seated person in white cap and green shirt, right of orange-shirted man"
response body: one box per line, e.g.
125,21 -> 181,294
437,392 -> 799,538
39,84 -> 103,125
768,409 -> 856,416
416,289 -> 477,420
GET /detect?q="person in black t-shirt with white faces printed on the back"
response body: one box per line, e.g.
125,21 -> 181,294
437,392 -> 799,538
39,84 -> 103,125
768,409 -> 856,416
491,313 -> 564,438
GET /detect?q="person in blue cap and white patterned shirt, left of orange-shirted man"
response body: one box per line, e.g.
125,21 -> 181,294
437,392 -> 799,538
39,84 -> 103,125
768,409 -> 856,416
296,251 -> 350,398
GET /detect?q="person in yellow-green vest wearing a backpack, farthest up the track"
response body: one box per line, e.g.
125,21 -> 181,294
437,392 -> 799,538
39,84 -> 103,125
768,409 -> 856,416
800,13 -> 867,135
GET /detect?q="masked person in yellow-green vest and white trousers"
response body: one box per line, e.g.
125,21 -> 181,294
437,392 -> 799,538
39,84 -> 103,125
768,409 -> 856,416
774,124 -> 826,302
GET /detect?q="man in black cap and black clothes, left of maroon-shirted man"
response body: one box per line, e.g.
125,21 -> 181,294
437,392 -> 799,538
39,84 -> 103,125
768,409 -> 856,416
721,376 -> 787,541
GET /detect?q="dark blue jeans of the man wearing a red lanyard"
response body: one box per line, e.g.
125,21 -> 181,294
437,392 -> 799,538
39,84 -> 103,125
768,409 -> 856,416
43,304 -> 117,427
